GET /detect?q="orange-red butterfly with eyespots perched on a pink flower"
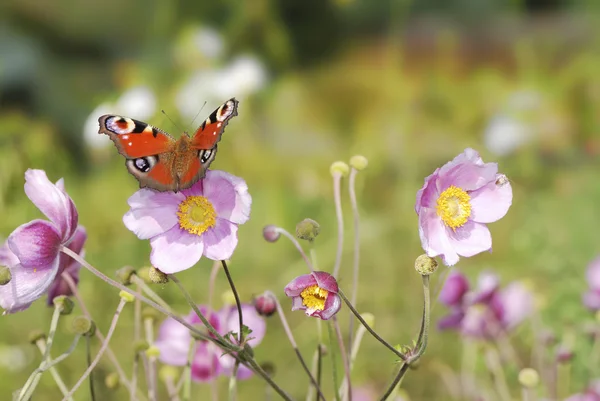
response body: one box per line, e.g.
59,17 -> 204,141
98,98 -> 238,192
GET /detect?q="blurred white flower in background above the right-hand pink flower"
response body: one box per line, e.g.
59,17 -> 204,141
483,114 -> 533,156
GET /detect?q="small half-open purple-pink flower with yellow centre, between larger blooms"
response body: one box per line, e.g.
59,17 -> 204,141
284,272 -> 342,320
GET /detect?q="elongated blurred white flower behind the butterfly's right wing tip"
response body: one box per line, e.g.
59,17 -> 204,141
175,56 -> 267,119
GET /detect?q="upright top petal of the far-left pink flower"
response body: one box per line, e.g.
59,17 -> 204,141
25,169 -> 78,241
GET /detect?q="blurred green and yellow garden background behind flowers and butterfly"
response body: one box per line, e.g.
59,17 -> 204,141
0,0 -> 600,401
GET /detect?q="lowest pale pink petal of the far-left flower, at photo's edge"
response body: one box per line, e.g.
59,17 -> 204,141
0,257 -> 59,313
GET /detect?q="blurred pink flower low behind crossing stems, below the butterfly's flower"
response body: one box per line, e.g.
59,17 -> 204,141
156,304 -> 266,382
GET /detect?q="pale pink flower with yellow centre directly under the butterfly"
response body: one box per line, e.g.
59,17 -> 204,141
123,170 -> 252,274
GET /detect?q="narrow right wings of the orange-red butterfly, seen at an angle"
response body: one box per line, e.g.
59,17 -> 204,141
172,98 -> 238,189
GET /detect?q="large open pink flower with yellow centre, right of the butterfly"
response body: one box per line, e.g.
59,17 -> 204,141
415,148 -> 512,266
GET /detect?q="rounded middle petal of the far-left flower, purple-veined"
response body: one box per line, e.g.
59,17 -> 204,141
7,220 -> 61,269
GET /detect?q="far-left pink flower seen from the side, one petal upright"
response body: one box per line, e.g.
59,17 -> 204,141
0,170 -> 85,313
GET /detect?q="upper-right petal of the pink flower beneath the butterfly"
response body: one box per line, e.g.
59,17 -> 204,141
202,170 -> 252,224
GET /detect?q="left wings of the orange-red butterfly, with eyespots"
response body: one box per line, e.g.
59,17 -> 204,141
98,114 -> 178,191
